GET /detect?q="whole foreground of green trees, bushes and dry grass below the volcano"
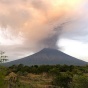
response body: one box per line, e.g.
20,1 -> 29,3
0,64 -> 88,88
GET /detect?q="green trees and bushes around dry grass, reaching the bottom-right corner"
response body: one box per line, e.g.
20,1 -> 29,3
7,64 -> 88,88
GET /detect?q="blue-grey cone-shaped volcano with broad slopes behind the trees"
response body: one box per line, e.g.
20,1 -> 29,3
4,48 -> 87,66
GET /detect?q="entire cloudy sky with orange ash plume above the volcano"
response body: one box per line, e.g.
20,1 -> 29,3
0,0 -> 88,62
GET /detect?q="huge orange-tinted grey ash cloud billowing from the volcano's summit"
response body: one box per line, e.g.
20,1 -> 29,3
0,0 -> 87,60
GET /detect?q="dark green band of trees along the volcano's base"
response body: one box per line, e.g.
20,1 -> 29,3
8,64 -> 88,75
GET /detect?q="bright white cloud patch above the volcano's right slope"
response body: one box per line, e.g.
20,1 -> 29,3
58,39 -> 88,62
